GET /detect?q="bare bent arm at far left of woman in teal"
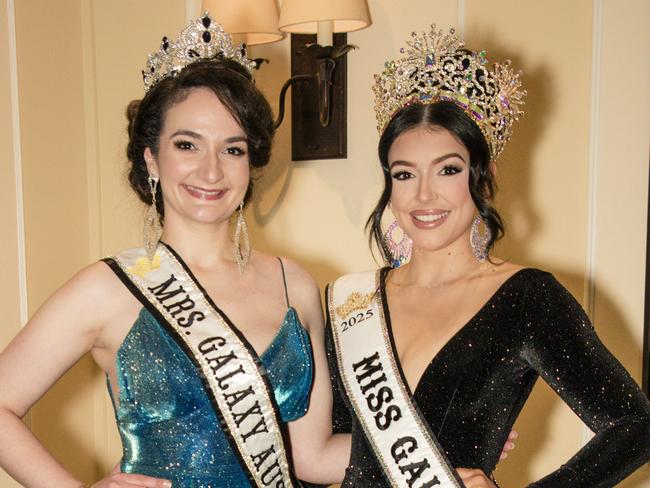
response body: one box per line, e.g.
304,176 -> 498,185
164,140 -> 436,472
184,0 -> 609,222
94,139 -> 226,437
0,263 -> 170,488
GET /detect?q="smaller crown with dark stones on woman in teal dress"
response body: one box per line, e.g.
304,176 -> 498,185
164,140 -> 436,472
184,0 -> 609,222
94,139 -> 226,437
142,12 -> 255,92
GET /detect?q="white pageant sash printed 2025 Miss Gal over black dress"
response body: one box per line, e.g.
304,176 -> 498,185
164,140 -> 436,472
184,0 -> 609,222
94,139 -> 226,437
327,272 -> 463,488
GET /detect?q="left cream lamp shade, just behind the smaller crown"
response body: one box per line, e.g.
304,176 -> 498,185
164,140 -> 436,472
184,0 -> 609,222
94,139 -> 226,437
201,0 -> 284,46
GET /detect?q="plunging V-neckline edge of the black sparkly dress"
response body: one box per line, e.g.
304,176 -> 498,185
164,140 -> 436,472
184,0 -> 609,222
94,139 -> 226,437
377,267 -> 531,398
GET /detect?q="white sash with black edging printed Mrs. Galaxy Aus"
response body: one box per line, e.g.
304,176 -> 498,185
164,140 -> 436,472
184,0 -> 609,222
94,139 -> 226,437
107,243 -> 300,488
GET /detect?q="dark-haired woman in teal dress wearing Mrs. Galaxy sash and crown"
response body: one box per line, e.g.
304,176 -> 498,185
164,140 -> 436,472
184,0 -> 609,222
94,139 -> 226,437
0,15 -> 349,488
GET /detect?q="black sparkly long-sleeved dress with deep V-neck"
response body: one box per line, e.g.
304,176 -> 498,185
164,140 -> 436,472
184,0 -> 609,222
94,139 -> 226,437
326,269 -> 650,488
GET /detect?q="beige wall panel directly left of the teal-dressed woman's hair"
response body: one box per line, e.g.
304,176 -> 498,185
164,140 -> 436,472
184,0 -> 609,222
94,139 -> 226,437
88,0 -> 185,473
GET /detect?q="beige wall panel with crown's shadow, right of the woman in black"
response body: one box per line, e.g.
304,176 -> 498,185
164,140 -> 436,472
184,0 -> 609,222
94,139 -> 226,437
465,0 -> 592,276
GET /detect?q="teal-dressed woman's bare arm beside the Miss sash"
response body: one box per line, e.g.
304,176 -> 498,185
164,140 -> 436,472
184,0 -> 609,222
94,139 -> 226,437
278,261 -> 351,484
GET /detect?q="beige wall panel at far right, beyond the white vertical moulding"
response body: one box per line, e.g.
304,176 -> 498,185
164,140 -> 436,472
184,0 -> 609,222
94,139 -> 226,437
594,0 -> 650,488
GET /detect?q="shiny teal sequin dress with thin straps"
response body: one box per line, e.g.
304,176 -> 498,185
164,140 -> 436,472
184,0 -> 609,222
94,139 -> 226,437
109,298 -> 313,488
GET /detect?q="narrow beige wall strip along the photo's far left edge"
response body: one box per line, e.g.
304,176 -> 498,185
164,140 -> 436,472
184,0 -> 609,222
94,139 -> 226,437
0,1 -> 21,488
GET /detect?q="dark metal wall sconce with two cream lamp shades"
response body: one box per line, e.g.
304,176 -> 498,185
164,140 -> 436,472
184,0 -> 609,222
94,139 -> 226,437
202,0 -> 371,161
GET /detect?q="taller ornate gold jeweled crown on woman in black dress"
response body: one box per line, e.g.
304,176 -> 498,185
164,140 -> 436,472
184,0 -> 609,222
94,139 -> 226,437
373,24 -> 526,160
